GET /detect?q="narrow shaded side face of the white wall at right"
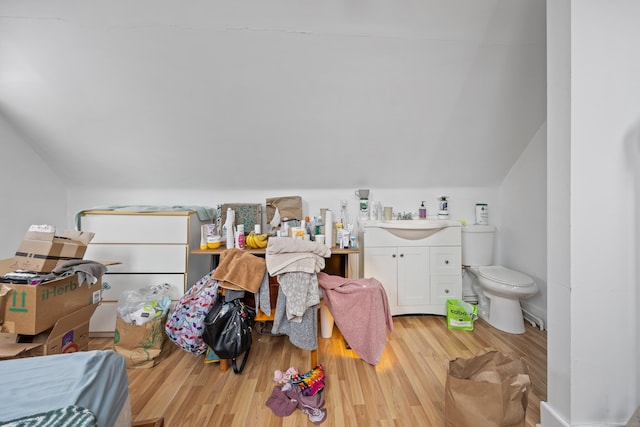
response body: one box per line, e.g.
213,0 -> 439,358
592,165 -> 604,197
540,0 -> 571,427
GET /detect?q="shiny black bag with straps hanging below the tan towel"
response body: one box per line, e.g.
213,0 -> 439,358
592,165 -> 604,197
202,296 -> 256,374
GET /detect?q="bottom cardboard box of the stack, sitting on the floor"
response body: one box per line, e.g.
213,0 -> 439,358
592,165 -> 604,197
0,304 -> 97,359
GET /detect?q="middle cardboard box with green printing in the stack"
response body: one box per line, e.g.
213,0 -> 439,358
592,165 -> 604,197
0,259 -> 102,335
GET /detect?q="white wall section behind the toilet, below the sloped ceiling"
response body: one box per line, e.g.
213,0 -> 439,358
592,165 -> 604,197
497,124 -> 547,325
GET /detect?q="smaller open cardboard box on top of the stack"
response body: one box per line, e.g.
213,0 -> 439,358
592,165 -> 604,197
11,230 -> 94,273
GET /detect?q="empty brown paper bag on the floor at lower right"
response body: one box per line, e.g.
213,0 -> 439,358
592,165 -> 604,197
444,351 -> 531,427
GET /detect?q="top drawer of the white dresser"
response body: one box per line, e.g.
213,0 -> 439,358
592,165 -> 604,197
80,213 -> 191,244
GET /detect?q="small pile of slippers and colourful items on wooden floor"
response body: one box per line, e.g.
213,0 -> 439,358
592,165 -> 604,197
266,365 -> 327,424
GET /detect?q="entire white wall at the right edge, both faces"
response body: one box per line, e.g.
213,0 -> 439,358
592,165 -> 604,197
541,0 -> 640,426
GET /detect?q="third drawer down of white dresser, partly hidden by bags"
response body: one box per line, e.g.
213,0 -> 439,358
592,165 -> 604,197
102,273 -> 185,301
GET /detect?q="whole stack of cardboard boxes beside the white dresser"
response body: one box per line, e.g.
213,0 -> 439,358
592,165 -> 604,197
0,226 -> 102,359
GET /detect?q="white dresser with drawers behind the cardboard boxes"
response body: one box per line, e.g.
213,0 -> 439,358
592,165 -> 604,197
80,210 -> 211,336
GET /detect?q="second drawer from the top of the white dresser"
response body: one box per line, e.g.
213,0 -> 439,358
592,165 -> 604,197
84,243 -> 188,273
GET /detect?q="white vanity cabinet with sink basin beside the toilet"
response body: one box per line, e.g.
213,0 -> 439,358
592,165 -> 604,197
363,221 -> 462,315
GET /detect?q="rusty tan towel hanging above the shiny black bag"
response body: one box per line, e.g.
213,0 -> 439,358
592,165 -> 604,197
211,248 -> 266,293
